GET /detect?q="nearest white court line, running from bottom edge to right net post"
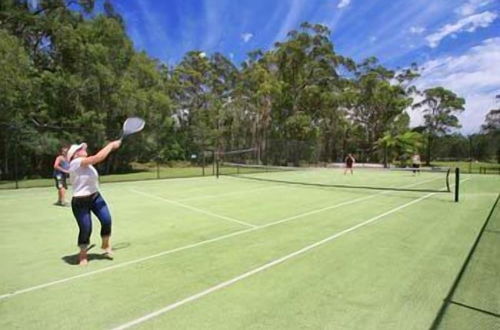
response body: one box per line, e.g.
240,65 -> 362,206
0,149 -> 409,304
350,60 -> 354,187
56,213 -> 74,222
113,188 -> 446,330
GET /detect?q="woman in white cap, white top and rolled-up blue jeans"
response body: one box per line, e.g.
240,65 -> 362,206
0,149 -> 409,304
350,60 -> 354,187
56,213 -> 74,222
67,140 -> 121,266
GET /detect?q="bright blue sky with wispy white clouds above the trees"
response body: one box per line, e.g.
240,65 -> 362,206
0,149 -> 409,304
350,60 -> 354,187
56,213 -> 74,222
113,0 -> 500,134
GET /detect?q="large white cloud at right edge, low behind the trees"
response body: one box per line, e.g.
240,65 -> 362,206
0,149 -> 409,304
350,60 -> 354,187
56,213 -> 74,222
411,37 -> 500,134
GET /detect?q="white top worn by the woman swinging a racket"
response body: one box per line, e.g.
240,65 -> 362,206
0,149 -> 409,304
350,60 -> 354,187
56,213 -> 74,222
69,158 -> 99,197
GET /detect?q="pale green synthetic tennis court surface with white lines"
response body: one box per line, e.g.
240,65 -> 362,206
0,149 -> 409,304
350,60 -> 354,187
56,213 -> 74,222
0,170 -> 500,329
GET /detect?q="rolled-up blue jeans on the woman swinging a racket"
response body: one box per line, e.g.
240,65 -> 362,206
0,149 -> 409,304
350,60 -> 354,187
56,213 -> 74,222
71,192 -> 111,248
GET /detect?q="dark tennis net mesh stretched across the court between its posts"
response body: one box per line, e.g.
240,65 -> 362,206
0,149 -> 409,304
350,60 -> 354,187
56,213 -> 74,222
218,149 -> 454,193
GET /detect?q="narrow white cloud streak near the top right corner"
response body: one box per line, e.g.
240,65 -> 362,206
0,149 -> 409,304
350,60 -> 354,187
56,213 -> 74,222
426,11 -> 498,48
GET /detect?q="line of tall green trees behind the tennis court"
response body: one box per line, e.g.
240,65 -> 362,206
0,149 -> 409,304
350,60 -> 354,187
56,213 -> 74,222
0,0 -> 500,179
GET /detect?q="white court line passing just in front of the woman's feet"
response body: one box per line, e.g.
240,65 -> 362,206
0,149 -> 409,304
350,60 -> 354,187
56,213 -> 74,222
0,179 -> 454,300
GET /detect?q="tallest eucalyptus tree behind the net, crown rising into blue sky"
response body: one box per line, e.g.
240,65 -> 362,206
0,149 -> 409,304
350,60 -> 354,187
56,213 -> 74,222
273,22 -> 354,162
